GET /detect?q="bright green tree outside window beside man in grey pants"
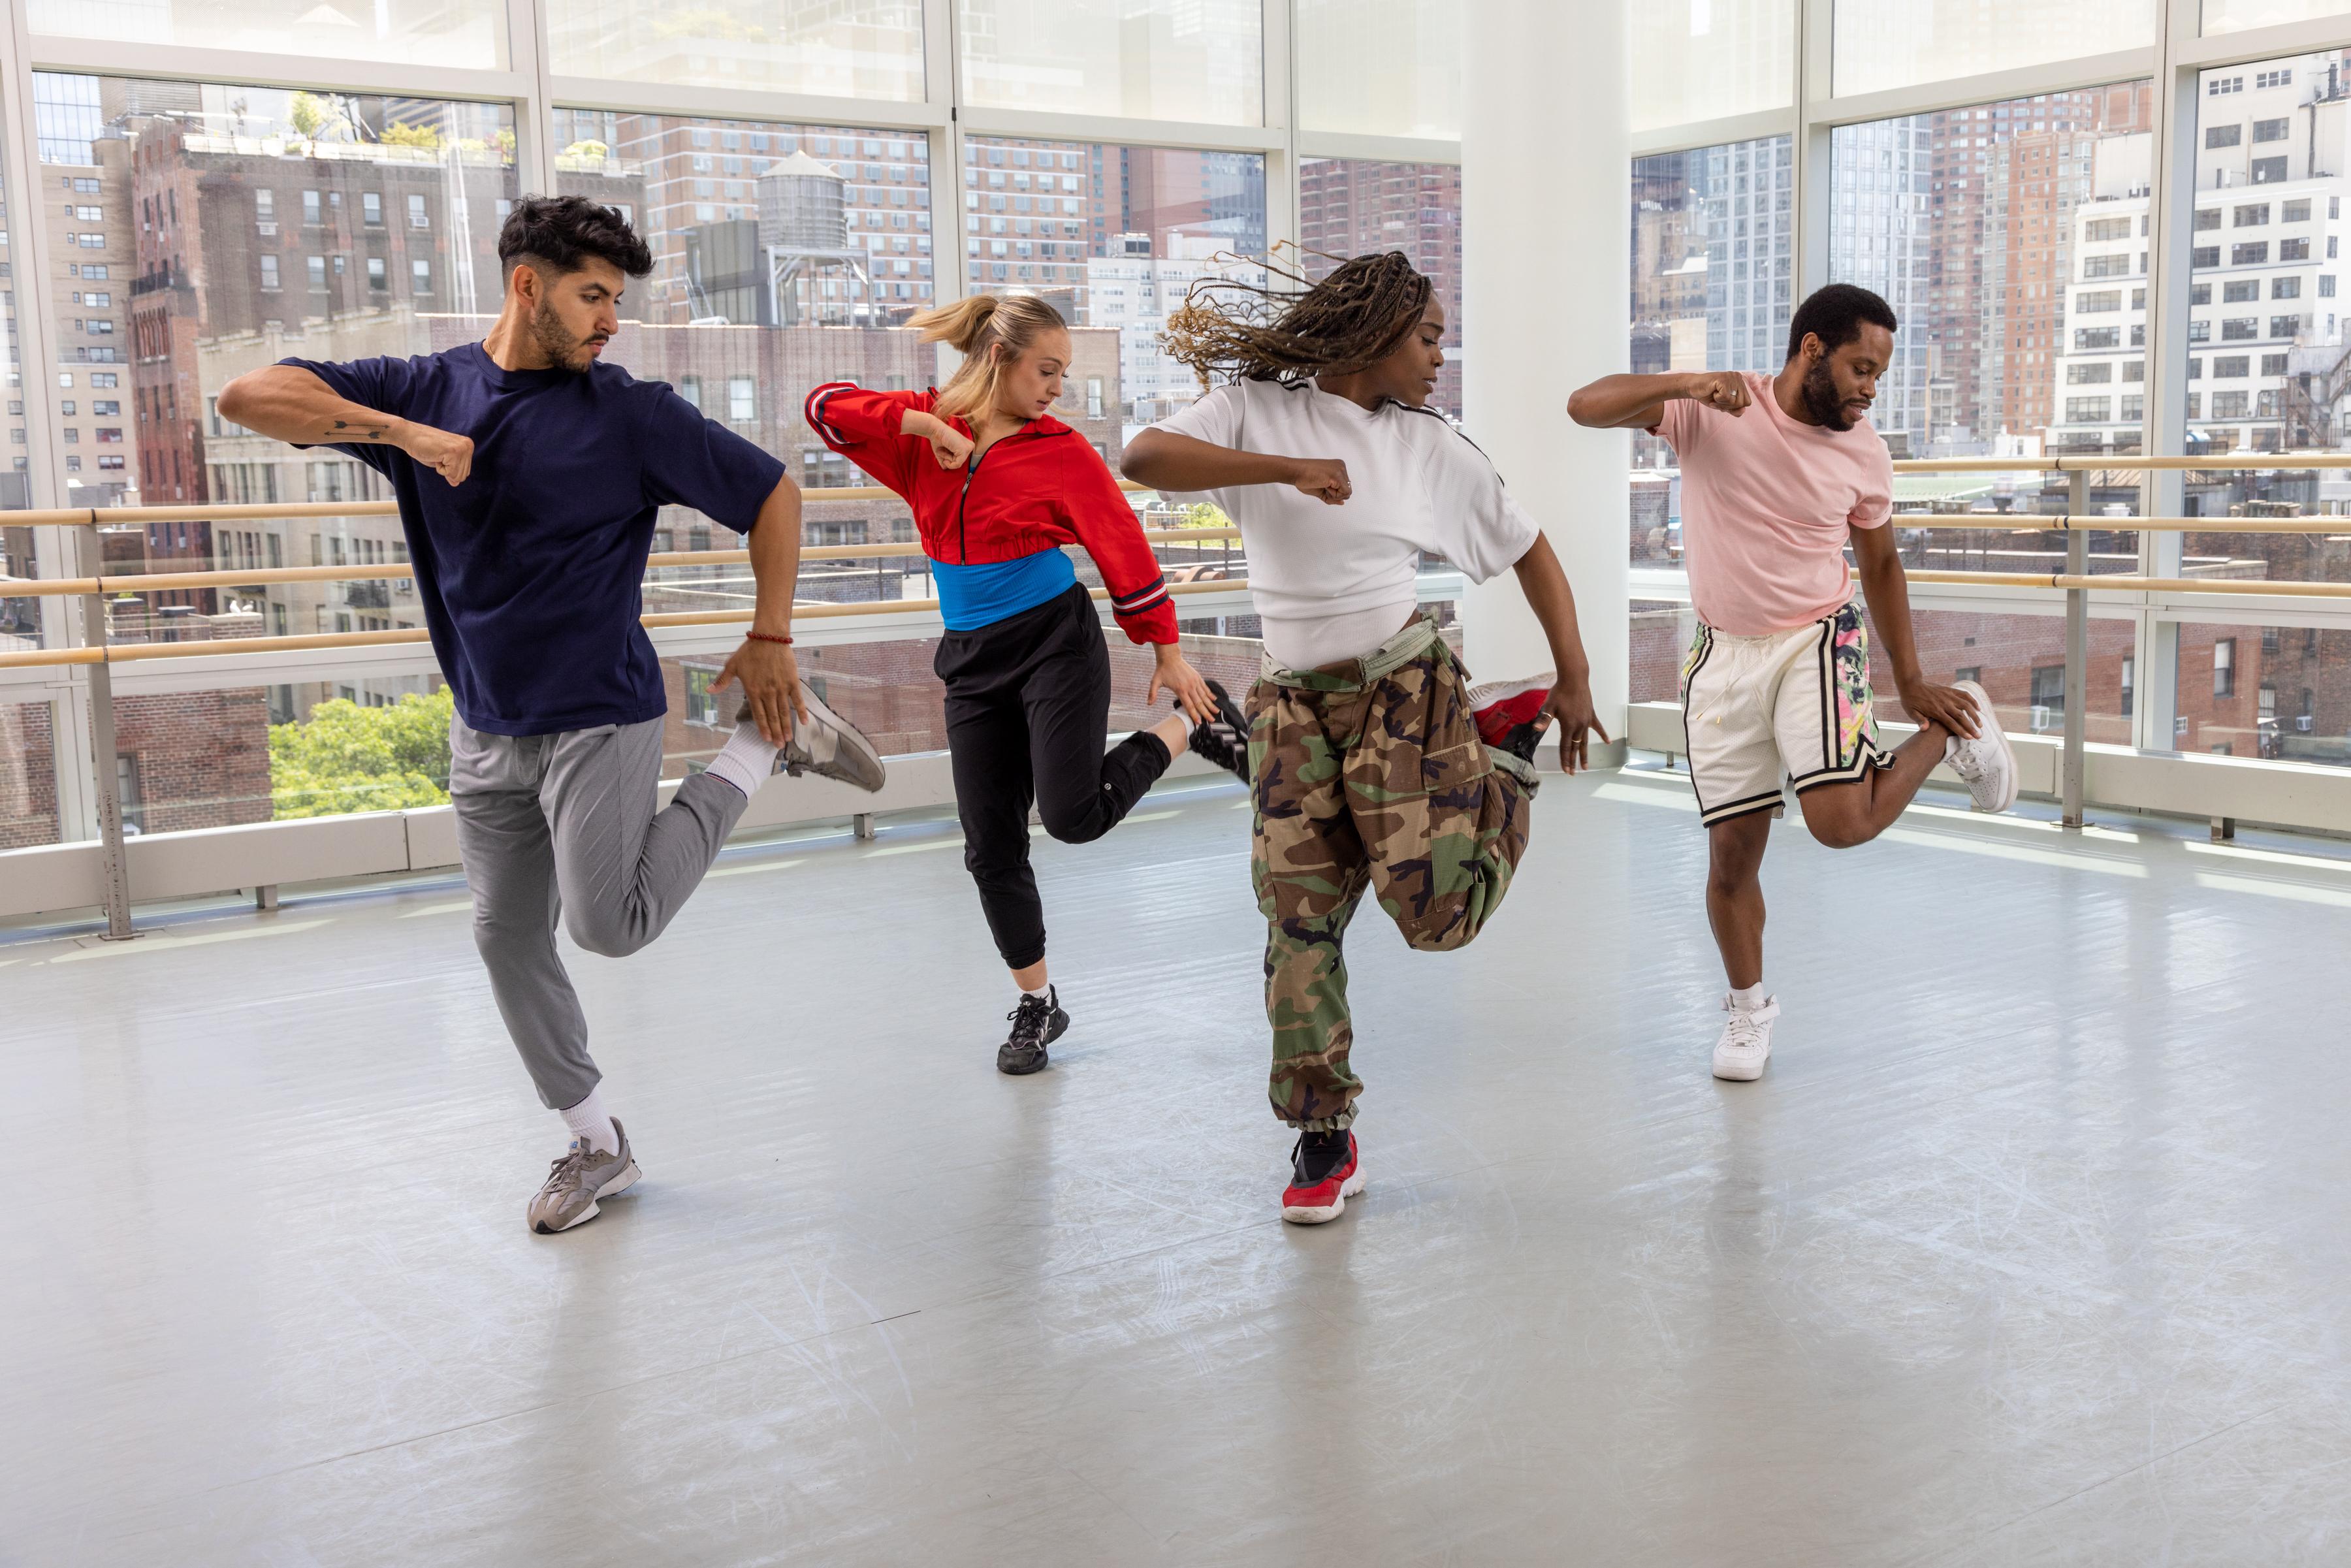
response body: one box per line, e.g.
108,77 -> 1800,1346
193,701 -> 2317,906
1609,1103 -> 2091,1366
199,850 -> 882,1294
270,686 -> 451,818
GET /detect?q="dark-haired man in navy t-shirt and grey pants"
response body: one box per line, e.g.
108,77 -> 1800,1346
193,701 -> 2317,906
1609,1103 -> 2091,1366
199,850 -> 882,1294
221,195 -> 882,1234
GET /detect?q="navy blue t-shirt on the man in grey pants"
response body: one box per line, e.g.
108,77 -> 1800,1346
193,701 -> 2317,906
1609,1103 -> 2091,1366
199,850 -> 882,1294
280,344 -> 783,736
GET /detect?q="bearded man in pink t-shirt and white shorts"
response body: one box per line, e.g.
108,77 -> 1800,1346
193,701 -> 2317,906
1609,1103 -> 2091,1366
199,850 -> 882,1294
1568,285 -> 2017,1079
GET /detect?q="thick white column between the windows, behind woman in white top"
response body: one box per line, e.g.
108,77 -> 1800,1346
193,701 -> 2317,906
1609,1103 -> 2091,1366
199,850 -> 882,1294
1462,0 -> 1631,738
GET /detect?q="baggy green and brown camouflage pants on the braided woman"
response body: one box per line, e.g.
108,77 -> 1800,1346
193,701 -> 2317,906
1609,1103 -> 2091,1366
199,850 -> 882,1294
1249,618 -> 1535,1130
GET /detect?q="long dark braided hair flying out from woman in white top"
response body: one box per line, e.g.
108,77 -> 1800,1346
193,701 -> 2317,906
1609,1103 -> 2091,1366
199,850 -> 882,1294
1159,251 -> 1431,391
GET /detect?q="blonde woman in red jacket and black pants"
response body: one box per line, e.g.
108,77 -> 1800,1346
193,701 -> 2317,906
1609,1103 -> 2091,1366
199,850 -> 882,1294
808,294 -> 1249,1072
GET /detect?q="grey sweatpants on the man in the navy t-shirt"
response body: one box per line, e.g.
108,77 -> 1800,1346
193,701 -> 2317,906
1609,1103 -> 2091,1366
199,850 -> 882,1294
449,720 -> 750,1110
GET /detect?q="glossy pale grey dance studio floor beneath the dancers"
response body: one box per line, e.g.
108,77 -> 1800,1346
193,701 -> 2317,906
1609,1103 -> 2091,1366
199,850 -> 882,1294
0,773 -> 2351,1568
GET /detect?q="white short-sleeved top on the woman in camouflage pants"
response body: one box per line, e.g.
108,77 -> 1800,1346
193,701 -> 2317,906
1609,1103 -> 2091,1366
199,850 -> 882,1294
1159,381 -> 1540,670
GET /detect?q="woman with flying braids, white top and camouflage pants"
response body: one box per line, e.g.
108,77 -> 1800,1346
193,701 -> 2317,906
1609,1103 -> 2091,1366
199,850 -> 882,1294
1126,251 -> 1608,1224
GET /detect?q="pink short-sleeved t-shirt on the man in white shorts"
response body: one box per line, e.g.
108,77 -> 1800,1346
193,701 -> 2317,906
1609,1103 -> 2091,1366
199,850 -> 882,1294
1657,374 -> 1895,637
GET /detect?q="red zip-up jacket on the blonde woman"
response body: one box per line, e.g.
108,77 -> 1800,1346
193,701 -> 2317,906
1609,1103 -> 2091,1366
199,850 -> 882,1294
808,381 -> 1176,642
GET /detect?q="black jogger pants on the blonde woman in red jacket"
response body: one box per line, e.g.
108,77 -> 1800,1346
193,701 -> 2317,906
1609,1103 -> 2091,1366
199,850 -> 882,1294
931,585 -> 1171,968
